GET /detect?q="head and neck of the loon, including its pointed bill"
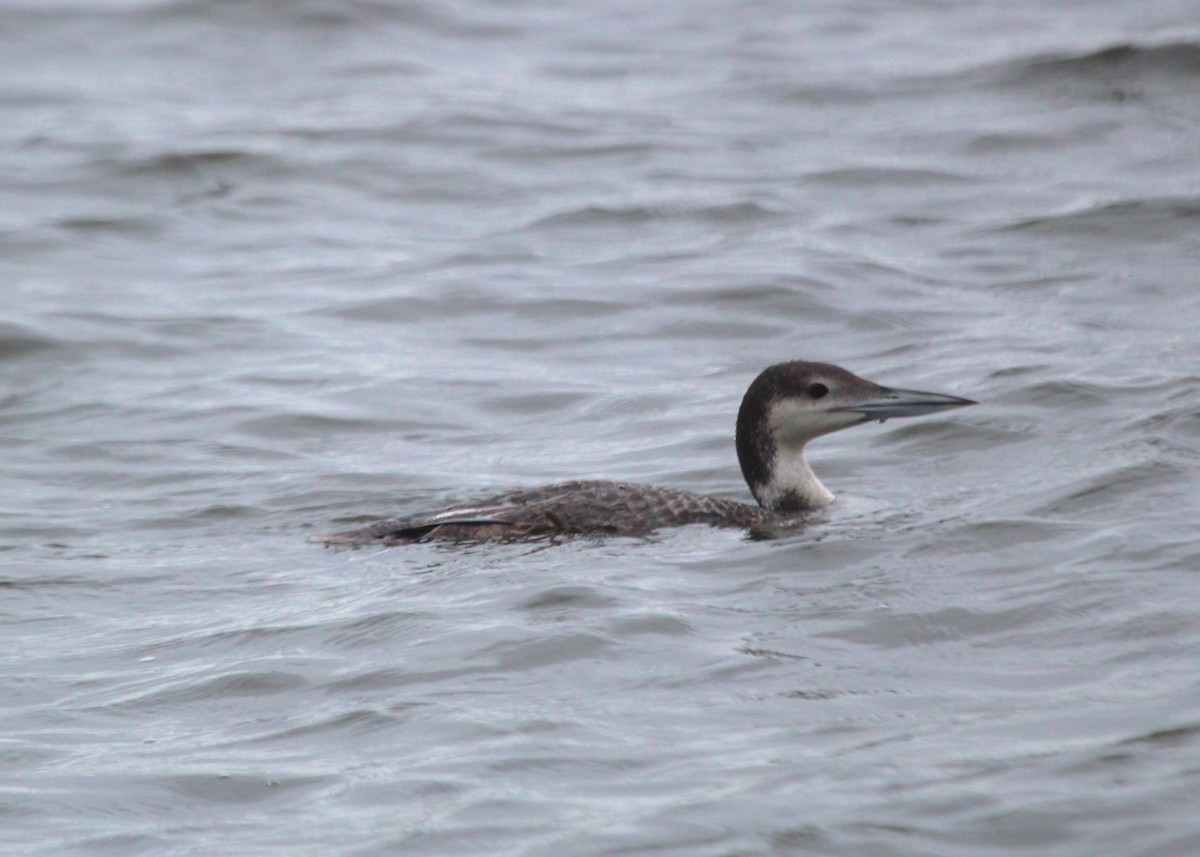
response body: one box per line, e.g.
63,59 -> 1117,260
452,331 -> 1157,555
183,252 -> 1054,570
737,361 -> 977,513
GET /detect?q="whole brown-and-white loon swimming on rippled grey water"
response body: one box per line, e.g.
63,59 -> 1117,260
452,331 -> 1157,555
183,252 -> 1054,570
325,361 -> 976,545
